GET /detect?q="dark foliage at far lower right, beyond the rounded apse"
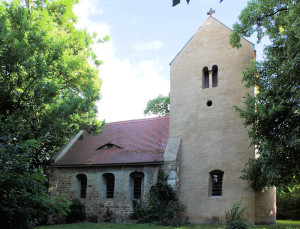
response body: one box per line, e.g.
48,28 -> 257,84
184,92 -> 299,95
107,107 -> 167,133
276,185 -> 300,220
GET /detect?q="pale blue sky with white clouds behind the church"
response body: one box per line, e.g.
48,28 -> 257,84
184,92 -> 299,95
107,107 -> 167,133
74,0 -> 264,122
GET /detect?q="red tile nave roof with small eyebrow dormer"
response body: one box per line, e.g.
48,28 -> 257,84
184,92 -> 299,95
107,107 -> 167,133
54,116 -> 169,166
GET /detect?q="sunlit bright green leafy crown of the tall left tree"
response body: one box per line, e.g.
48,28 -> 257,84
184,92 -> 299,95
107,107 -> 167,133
0,0 -> 101,174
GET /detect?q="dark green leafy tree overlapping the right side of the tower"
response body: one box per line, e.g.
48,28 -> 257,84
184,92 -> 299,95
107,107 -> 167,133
230,0 -> 300,189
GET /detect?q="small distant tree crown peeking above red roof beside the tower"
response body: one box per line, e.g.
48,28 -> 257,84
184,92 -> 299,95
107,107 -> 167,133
144,95 -> 170,116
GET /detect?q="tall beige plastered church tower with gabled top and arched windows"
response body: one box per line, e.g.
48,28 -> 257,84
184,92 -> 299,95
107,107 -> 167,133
168,16 -> 276,223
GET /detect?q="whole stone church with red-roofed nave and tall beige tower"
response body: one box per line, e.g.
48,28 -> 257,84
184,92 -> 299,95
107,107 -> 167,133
49,16 -> 276,224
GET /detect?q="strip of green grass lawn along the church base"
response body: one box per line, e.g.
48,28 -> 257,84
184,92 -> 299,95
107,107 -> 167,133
35,220 -> 300,229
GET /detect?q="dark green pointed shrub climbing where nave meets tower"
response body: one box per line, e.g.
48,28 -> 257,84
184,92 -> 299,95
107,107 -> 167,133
132,170 -> 186,225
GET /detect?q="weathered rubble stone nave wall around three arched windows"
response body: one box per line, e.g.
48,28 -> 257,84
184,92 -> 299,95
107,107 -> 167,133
49,165 -> 159,218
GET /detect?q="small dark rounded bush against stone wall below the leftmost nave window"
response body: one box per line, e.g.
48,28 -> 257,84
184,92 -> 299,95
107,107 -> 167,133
66,199 -> 86,223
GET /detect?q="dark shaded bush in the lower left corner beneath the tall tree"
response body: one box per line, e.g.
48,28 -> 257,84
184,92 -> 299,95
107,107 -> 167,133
0,157 -> 69,229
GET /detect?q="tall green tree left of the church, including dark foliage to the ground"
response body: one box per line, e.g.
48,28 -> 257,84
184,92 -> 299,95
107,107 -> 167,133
0,0 -> 101,228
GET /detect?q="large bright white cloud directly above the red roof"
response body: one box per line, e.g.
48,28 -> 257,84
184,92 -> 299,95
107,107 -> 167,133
98,46 -> 169,122
